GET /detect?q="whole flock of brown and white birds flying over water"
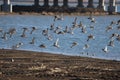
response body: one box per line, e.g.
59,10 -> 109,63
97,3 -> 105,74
0,15 -> 120,56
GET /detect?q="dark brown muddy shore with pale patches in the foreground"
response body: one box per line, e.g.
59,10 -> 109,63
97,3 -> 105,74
0,49 -> 120,80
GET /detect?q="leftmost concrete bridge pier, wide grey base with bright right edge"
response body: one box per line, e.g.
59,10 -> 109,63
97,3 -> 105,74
1,0 -> 12,13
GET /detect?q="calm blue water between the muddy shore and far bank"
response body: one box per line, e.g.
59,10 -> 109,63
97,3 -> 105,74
0,15 -> 120,60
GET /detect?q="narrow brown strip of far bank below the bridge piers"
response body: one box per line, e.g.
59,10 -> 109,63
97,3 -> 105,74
0,11 -> 120,16
